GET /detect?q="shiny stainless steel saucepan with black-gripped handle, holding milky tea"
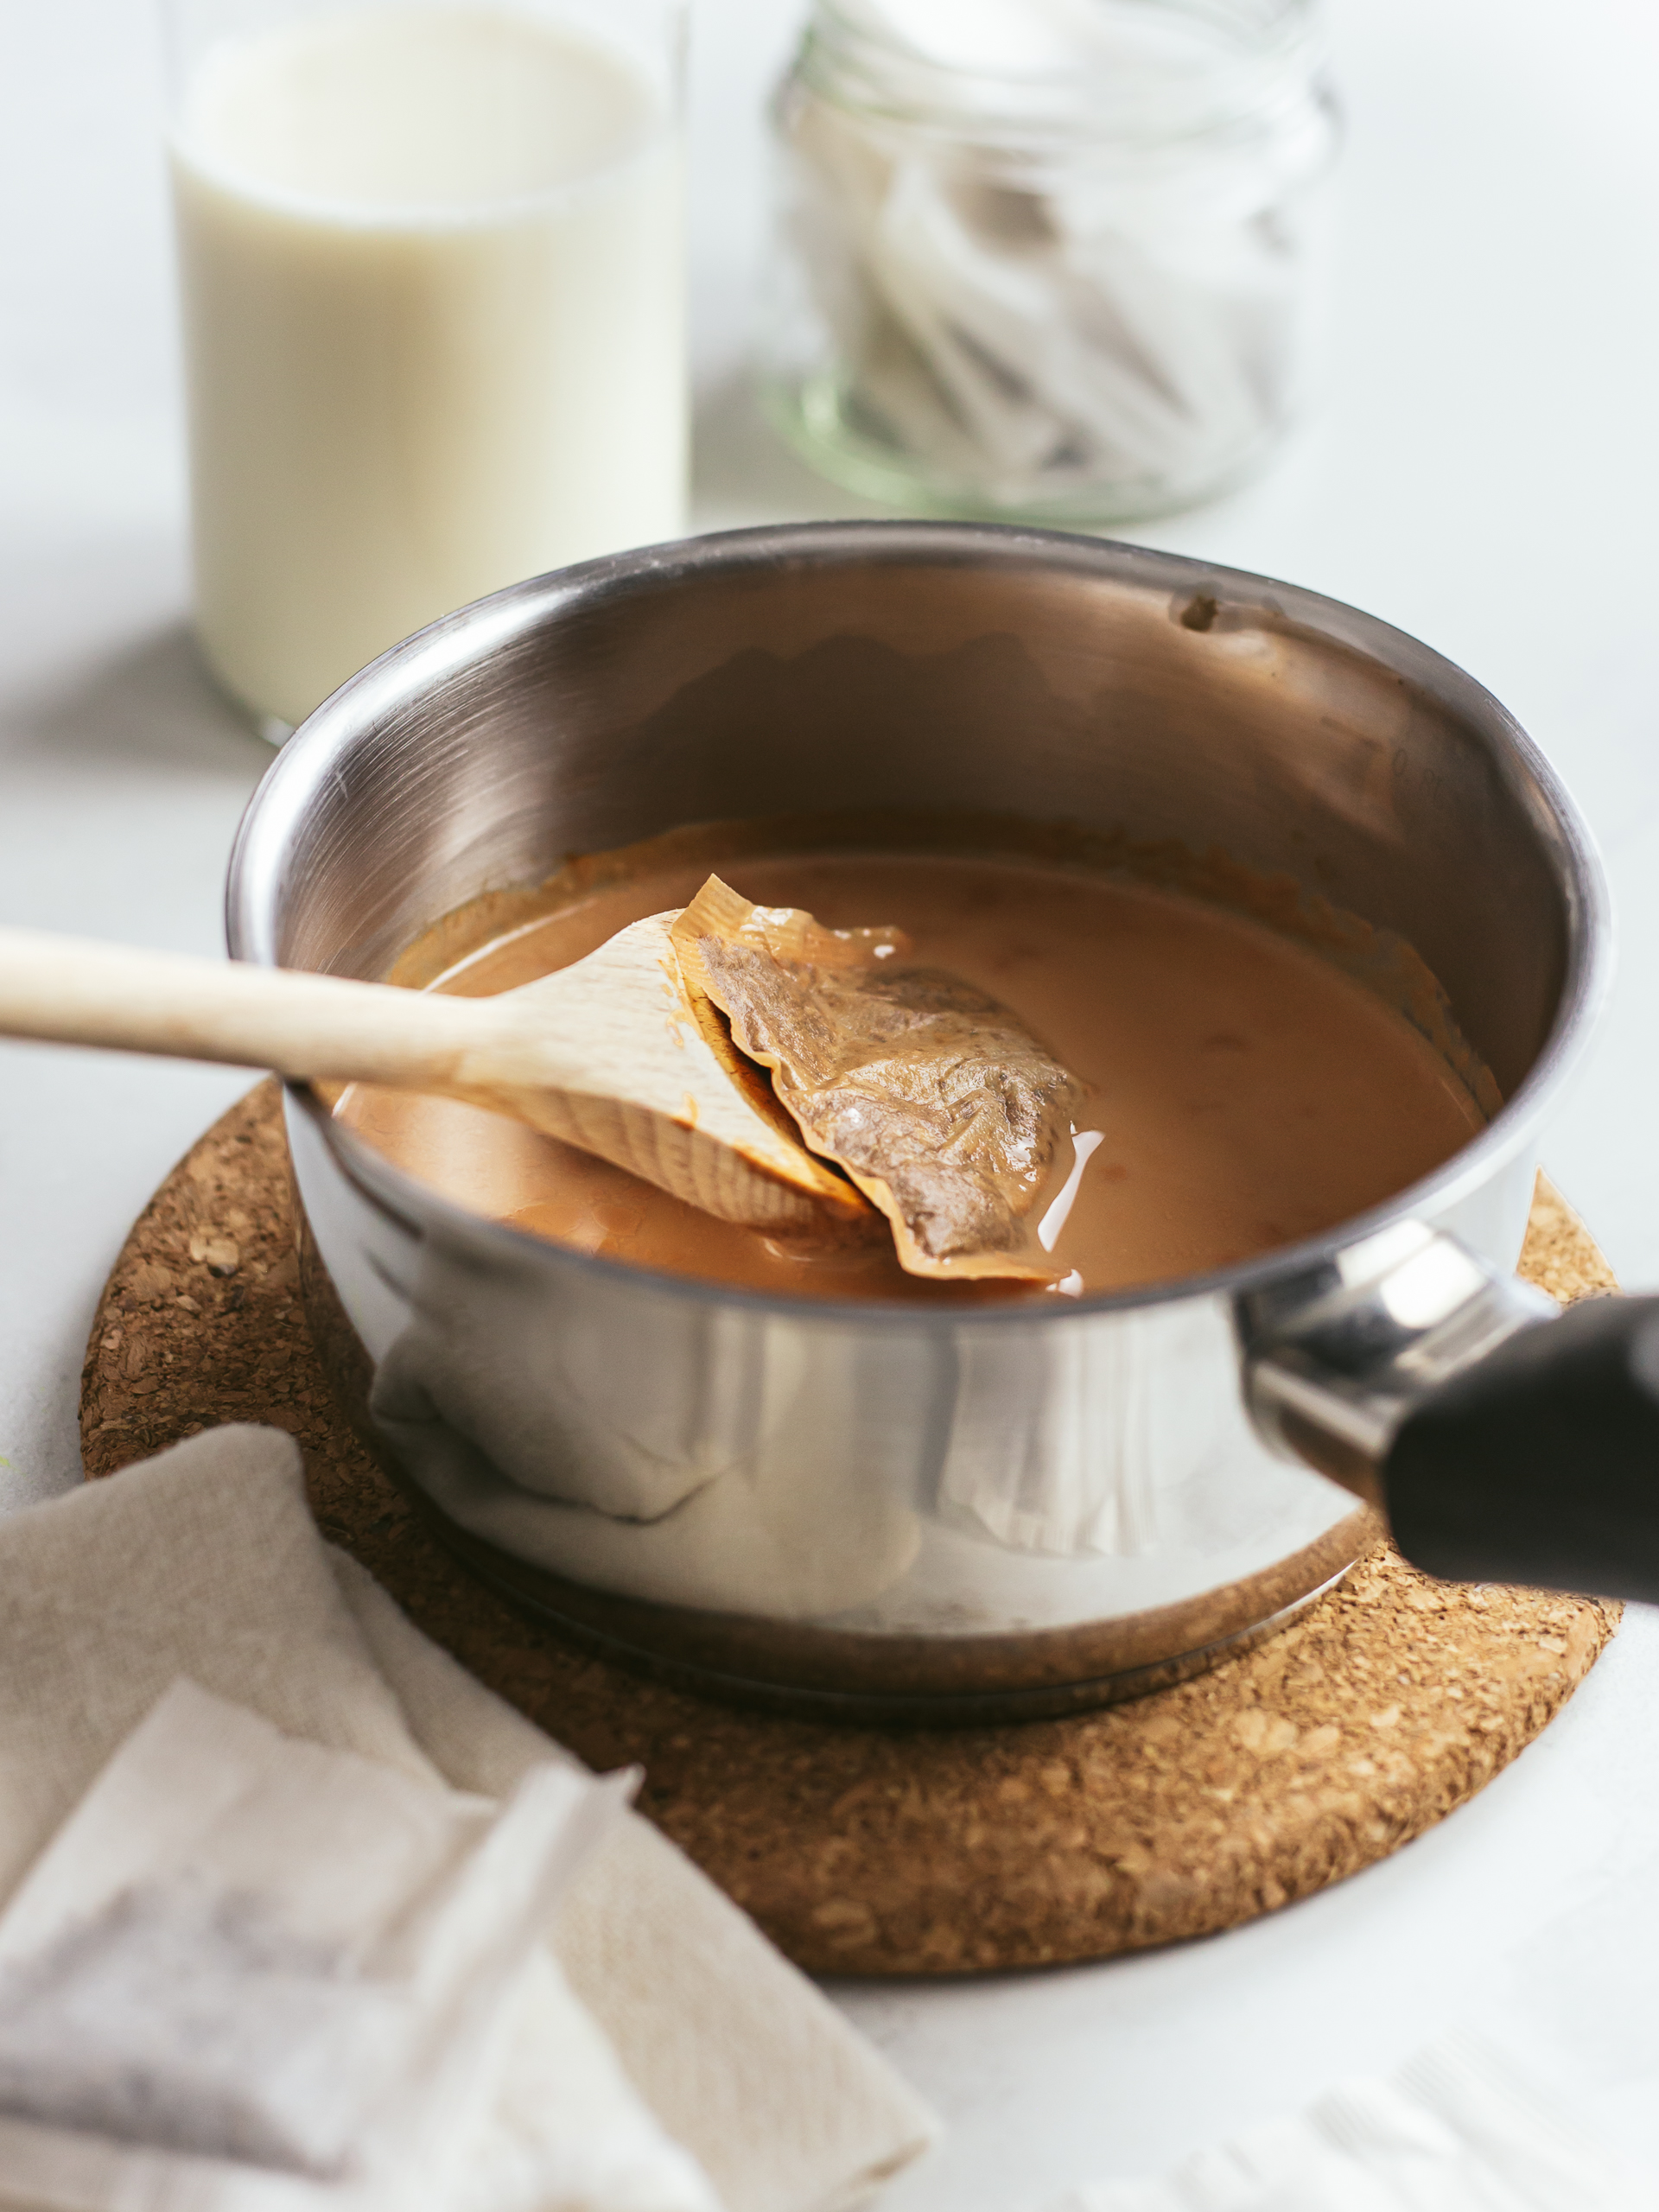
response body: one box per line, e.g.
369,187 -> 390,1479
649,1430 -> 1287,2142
228,524 -> 1659,1721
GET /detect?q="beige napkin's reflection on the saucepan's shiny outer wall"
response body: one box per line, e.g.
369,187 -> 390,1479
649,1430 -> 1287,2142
370,1239 -> 933,1619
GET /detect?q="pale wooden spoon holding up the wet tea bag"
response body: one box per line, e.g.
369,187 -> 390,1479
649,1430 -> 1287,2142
0,913 -> 872,1234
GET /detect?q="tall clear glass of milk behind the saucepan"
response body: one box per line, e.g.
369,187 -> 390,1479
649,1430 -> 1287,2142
168,0 -> 688,741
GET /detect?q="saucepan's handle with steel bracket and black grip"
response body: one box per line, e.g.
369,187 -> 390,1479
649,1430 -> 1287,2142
1236,1224 -> 1659,1601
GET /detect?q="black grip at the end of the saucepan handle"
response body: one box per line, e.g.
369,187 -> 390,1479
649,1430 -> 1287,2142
1382,1299 -> 1659,1604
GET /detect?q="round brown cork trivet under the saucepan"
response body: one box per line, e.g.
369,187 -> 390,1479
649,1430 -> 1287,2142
82,1084 -> 1619,1974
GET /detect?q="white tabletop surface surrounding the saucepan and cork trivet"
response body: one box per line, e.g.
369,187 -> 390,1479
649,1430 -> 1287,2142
0,0 -> 1659,2212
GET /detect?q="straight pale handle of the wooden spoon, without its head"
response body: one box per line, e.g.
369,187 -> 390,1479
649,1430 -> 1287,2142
0,929 -> 489,1090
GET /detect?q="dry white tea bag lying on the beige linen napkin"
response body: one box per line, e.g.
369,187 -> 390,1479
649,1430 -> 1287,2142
0,1676 -> 650,2212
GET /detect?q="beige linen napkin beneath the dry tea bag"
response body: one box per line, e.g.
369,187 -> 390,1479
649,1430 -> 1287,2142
0,1427 -> 936,2212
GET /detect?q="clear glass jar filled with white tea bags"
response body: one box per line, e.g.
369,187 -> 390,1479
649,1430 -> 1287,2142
763,0 -> 1338,522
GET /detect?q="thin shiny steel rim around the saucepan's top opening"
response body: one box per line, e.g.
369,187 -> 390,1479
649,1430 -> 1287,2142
226,522 -> 1612,1332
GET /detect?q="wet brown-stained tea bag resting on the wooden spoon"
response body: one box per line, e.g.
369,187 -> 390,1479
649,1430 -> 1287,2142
668,876 -> 1084,1283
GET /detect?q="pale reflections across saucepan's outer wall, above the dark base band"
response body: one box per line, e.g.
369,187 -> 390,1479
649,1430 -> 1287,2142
289,1109 -> 1407,1637
